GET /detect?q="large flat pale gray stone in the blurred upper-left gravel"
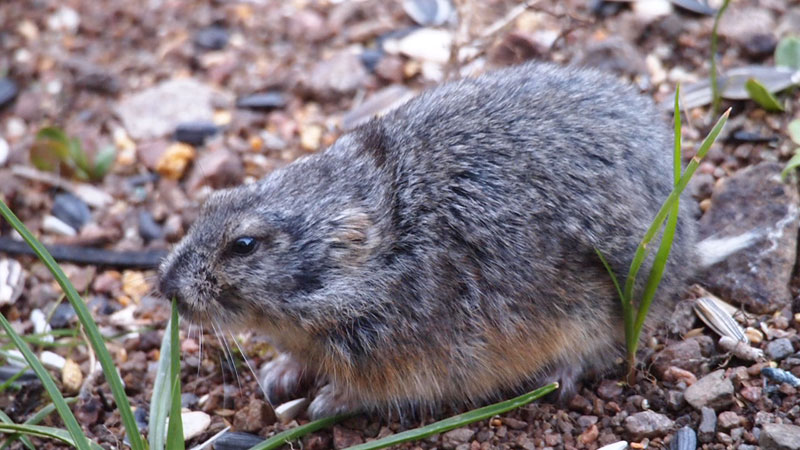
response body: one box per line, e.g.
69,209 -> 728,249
116,78 -> 214,139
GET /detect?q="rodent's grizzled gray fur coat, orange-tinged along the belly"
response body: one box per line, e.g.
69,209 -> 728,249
161,63 -> 695,416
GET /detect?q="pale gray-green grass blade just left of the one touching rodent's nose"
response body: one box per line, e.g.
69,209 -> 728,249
147,319 -> 172,450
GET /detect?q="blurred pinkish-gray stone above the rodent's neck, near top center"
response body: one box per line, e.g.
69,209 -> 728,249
308,50 -> 368,100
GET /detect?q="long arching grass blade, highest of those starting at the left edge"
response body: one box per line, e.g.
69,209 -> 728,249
0,200 -> 146,450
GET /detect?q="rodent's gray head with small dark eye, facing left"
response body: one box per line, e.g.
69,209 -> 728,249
159,144 -> 379,329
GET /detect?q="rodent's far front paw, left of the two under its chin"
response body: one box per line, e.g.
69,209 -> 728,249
259,353 -> 313,405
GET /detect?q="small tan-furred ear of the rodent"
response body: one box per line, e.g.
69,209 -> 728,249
328,208 -> 377,265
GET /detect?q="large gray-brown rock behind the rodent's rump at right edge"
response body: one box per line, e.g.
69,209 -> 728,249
700,162 -> 800,313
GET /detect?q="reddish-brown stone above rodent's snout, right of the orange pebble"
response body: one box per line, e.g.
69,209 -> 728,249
186,148 -> 244,192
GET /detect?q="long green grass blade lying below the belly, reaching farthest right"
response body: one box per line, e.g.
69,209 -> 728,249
349,383 -> 558,450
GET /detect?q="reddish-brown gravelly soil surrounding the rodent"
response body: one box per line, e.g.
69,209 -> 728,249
0,0 -> 800,450
